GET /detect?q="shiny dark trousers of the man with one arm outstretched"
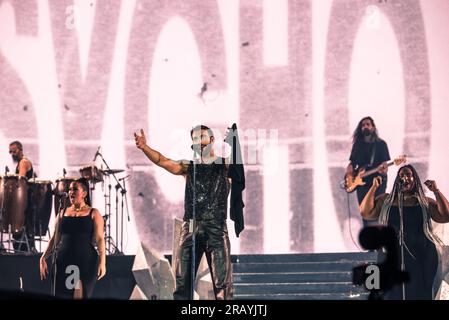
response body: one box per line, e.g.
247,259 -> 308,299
173,220 -> 232,300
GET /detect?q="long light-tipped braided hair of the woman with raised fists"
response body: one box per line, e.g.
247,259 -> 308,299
379,164 -> 444,246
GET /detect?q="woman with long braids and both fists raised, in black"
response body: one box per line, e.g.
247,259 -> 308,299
360,165 -> 449,300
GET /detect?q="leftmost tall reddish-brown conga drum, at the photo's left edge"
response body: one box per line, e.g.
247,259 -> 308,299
0,174 -> 28,234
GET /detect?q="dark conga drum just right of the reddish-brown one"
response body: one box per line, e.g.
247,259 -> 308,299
25,179 -> 53,236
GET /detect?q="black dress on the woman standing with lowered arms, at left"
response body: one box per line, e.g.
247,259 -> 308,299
56,209 -> 98,299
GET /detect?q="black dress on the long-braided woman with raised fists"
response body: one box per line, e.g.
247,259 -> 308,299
385,205 -> 438,300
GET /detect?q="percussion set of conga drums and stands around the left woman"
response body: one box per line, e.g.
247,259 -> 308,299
0,165 -> 125,253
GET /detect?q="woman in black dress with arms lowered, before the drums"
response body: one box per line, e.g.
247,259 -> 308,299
40,179 -> 106,299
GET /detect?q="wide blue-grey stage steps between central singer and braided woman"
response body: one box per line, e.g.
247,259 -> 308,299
232,252 -> 378,300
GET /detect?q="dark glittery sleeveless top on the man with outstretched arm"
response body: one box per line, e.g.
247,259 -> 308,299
184,158 -> 230,221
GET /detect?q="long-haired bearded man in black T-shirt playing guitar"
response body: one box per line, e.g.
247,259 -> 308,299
346,117 -> 390,227
